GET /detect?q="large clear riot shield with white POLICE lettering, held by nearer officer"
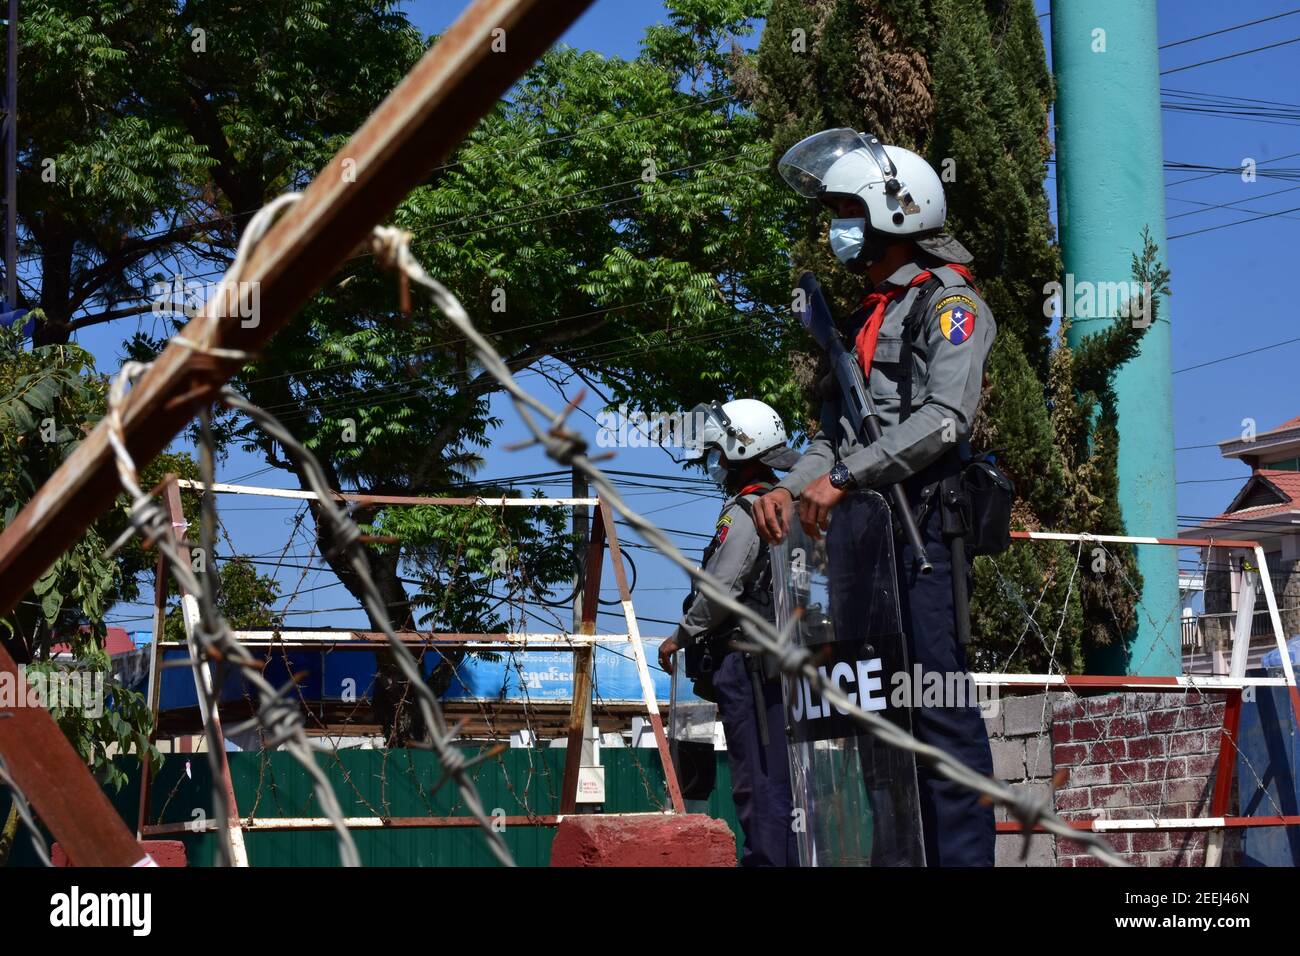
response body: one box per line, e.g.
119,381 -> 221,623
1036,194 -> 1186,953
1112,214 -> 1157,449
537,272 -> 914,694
772,492 -> 926,866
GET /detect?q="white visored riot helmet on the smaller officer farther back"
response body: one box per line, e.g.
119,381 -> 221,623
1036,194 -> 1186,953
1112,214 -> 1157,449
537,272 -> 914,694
685,398 -> 798,485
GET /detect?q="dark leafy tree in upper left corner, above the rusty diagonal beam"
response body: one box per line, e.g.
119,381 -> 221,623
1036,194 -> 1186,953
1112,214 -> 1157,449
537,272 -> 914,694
18,0 -> 421,343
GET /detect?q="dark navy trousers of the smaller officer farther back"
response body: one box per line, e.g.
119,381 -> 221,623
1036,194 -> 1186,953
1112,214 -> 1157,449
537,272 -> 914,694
714,650 -> 798,866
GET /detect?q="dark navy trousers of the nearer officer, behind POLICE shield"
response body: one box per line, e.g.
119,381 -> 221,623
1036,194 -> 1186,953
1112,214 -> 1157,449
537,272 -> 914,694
896,507 -> 996,866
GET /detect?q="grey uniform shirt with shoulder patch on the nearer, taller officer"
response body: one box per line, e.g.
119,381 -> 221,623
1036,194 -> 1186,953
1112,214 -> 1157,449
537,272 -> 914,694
776,263 -> 997,498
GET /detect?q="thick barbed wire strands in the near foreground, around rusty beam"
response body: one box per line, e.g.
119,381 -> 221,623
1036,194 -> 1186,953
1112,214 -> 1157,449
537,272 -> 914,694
94,179 -> 1227,865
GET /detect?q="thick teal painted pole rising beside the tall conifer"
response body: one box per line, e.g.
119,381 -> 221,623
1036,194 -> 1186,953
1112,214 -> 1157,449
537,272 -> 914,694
1052,0 -> 1182,675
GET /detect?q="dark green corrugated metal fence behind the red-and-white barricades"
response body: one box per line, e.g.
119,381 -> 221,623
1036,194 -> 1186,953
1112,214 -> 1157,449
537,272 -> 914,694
0,748 -> 741,866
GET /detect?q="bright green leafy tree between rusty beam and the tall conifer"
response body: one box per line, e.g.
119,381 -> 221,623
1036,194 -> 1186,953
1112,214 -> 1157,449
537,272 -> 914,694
126,1 -> 800,740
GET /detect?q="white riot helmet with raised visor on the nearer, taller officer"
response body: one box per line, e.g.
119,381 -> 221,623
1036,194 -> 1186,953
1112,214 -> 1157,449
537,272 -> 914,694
777,129 -> 971,267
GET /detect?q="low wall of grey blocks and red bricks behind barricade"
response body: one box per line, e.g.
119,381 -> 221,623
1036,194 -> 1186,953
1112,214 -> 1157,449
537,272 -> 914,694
985,693 -> 1239,866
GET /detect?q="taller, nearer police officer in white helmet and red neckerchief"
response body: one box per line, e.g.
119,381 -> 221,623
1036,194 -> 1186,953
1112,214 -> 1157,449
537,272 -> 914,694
754,129 -> 996,866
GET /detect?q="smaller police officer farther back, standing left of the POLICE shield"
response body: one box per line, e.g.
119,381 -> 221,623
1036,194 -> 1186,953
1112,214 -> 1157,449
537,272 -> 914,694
659,398 -> 798,866
